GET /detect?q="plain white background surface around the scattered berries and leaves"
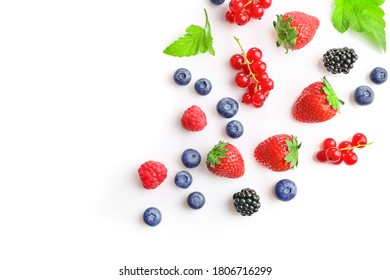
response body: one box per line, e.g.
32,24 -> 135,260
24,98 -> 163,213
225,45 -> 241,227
0,0 -> 390,280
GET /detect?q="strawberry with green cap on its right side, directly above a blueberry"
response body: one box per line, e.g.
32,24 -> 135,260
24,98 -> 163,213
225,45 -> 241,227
254,134 -> 302,172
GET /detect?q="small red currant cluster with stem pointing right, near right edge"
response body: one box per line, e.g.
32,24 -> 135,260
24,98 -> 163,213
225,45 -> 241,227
316,133 -> 373,165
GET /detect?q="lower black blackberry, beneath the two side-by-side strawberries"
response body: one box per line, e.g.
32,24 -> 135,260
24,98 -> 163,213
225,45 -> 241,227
233,188 -> 261,216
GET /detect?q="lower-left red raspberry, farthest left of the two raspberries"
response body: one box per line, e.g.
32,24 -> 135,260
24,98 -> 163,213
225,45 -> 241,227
138,160 -> 168,189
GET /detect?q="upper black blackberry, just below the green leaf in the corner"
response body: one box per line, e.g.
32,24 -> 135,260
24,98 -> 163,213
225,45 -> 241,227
322,47 -> 358,74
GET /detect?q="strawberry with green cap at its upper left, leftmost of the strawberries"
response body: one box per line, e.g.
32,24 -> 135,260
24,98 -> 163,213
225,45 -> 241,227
206,141 -> 245,178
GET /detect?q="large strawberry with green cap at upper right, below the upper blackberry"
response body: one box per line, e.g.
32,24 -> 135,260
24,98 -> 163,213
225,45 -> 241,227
292,77 -> 344,123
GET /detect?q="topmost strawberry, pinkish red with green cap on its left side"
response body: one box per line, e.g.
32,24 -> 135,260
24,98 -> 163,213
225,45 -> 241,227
273,11 -> 320,53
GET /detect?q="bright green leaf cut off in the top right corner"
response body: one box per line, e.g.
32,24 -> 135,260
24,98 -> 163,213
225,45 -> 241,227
332,0 -> 386,51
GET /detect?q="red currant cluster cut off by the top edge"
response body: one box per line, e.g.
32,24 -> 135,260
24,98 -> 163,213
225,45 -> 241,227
225,0 -> 272,25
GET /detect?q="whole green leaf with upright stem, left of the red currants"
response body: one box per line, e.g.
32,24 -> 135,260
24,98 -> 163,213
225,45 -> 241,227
163,9 -> 215,57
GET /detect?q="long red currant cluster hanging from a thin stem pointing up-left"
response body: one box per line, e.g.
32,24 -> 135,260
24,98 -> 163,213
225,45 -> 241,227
229,37 -> 274,108
